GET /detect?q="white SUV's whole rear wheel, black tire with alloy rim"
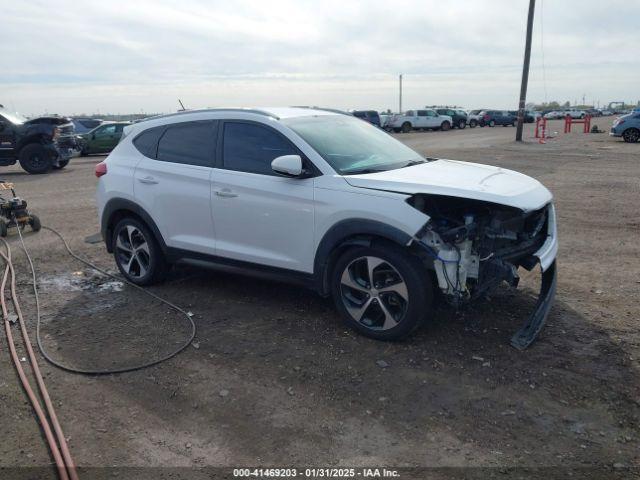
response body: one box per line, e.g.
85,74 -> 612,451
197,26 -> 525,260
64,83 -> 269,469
112,217 -> 167,285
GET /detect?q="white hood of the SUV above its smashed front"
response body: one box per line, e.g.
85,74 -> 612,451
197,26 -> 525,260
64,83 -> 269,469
344,160 -> 553,211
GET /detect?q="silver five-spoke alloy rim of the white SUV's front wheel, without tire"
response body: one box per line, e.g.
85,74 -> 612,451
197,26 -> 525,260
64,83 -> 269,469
340,256 -> 409,330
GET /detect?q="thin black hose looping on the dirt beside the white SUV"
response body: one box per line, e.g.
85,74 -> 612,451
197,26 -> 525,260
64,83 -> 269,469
17,225 -> 196,375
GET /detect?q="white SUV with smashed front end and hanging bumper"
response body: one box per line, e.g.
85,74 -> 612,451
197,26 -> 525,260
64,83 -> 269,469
96,108 -> 557,348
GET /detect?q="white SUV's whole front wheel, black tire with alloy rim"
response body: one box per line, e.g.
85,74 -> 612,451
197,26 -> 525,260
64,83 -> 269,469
331,245 -> 433,340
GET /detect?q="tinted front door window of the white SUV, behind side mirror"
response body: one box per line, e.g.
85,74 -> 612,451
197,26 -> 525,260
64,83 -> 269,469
222,122 -> 299,175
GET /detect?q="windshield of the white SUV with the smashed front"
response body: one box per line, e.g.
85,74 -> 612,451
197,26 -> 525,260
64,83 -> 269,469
283,115 -> 425,175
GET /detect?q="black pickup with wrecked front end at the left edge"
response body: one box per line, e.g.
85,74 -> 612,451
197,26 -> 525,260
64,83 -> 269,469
0,108 -> 71,174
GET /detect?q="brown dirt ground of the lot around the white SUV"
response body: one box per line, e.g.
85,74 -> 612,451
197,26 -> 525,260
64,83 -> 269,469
0,118 -> 640,479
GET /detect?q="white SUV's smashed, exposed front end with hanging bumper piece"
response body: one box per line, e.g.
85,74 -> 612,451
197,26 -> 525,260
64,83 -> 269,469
408,194 -> 557,350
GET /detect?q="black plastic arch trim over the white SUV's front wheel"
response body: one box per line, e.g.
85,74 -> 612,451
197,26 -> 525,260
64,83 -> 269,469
313,218 -> 411,295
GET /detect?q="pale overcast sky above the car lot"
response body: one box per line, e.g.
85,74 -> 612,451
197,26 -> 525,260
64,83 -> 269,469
0,0 -> 640,114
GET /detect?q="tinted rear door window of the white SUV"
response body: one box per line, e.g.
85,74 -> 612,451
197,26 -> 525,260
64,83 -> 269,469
157,121 -> 216,167
